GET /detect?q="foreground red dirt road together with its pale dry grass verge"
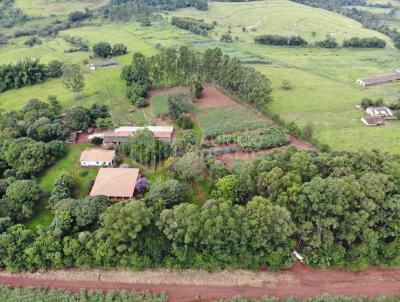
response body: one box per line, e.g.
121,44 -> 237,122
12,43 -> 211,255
0,264 -> 400,301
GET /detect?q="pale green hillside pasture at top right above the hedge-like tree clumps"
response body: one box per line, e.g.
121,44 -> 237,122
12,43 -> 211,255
167,0 -> 390,42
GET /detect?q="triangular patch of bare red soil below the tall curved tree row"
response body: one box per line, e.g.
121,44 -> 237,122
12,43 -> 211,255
196,83 -> 237,109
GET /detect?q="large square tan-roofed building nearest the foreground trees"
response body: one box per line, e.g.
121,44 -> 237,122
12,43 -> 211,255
90,168 -> 139,201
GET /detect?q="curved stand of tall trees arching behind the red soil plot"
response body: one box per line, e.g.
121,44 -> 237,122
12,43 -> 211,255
122,46 -> 272,107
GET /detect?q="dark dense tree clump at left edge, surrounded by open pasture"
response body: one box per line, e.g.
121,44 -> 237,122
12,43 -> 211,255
0,58 -> 63,92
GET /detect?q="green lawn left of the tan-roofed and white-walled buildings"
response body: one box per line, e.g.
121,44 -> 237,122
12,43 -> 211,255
25,145 -> 97,230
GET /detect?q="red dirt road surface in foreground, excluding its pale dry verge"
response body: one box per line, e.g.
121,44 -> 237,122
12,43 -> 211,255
0,264 -> 400,302
